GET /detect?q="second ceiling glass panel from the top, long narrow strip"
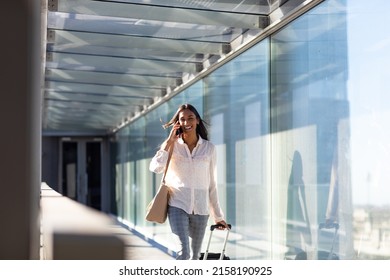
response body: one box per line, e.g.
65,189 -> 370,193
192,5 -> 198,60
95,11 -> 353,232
48,10 -> 241,43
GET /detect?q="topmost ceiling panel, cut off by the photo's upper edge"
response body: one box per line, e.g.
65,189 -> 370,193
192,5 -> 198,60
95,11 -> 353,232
53,0 -> 268,28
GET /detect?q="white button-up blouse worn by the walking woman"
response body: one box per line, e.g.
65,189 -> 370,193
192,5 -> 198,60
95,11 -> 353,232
149,137 -> 224,223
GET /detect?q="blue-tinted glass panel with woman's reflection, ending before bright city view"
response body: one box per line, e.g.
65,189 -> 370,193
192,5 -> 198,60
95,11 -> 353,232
271,1 -> 353,259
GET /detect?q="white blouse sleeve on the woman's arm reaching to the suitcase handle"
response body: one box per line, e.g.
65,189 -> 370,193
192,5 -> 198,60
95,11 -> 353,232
209,147 -> 225,223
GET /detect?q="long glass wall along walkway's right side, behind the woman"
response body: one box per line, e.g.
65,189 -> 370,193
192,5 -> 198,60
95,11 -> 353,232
112,0 -> 390,259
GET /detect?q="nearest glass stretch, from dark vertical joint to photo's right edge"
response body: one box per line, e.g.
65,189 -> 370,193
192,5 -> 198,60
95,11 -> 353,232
271,1 -> 390,259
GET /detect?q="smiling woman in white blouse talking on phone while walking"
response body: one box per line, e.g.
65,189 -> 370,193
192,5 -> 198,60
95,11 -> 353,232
149,104 -> 227,260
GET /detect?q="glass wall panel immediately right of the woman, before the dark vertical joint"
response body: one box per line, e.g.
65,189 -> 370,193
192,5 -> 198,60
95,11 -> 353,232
205,40 -> 271,259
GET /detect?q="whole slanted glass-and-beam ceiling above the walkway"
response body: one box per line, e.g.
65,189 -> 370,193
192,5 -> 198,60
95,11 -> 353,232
42,0 -> 302,135
